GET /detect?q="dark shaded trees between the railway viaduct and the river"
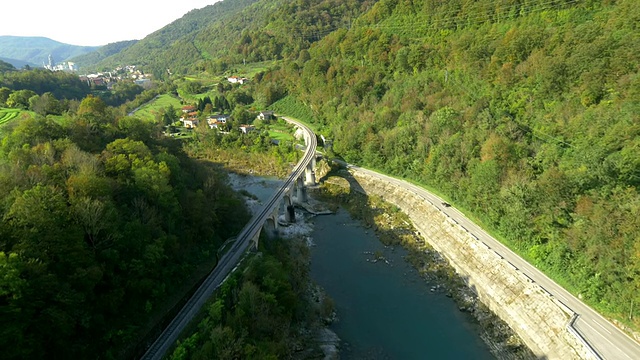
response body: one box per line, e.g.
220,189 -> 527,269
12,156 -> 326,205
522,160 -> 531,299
170,235 -> 333,360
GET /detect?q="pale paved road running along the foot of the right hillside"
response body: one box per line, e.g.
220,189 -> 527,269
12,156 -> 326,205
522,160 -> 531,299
348,165 -> 640,360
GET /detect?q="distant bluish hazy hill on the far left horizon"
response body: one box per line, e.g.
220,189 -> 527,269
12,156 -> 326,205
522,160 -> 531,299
0,36 -> 99,67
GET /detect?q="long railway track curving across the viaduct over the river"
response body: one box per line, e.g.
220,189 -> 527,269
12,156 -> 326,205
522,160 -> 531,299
142,118 -> 318,360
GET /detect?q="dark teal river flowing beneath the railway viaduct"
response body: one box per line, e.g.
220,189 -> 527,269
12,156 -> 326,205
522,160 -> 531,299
232,175 -> 494,359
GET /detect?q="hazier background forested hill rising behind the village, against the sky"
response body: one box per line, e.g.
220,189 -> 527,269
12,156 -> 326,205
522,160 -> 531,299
97,0 -> 373,78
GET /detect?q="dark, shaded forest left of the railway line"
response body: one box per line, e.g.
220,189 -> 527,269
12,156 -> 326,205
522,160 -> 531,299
0,96 -> 249,359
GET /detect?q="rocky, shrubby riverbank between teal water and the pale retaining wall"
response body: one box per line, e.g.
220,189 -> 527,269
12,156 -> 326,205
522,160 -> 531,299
311,178 -> 536,359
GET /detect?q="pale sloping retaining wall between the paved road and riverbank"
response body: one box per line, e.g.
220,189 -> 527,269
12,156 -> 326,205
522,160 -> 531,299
350,170 -> 593,359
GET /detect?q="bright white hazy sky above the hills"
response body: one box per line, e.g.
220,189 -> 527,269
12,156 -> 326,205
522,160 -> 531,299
0,0 -> 218,46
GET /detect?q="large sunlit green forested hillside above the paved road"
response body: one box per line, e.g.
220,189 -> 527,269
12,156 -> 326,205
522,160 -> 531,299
260,0 -> 640,326
